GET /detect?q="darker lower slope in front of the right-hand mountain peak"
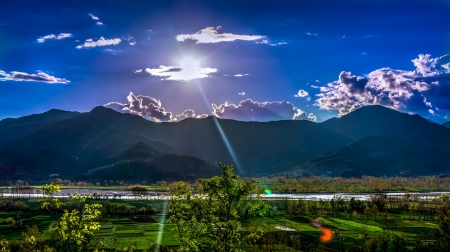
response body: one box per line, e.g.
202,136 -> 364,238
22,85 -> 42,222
307,136 -> 450,177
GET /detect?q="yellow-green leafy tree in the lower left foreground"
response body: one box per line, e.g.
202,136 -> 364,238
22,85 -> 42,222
49,193 -> 102,251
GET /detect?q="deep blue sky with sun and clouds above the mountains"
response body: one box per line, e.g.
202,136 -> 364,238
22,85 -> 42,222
0,0 -> 450,123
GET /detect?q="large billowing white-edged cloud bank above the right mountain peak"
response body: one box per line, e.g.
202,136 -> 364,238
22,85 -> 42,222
315,54 -> 450,116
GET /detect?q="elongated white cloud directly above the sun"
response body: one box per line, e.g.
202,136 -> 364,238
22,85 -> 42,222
176,27 -> 265,44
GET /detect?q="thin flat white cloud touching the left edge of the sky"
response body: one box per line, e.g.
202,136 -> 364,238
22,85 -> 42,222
0,70 -> 70,84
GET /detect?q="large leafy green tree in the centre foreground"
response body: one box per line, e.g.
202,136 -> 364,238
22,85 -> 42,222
168,163 -> 269,252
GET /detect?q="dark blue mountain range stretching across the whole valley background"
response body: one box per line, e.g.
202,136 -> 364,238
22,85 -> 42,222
0,106 -> 450,181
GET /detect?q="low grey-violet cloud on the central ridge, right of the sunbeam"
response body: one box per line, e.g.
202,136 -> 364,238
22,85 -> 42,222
211,99 -> 314,121
